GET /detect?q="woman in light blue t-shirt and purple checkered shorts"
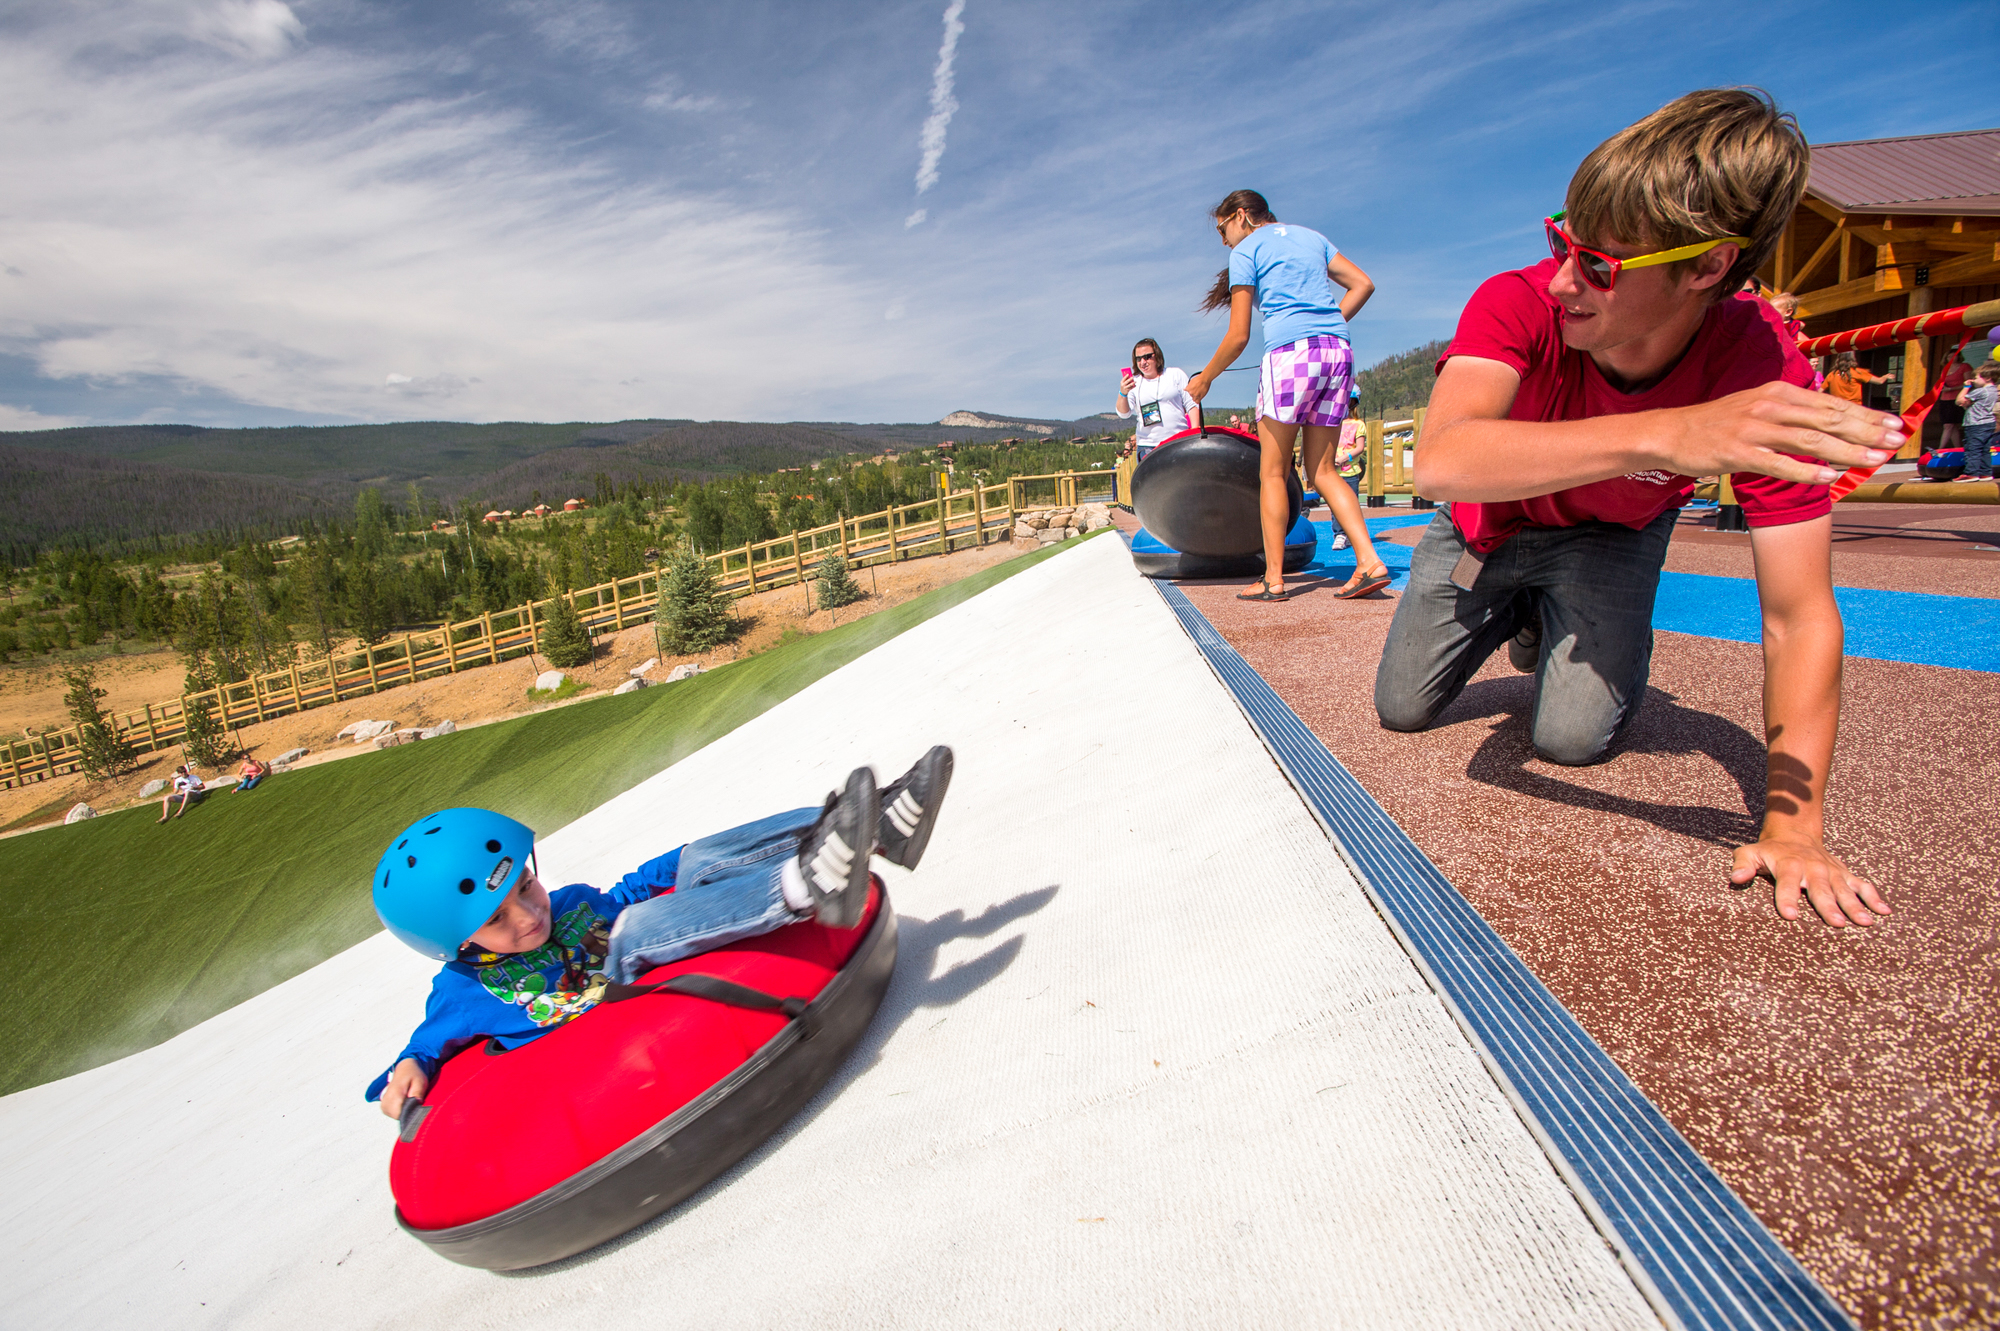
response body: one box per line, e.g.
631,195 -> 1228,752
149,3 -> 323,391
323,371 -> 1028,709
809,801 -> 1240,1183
1188,190 -> 1390,602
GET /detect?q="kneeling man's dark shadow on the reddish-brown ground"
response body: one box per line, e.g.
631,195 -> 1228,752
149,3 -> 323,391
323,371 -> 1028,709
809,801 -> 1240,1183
1438,677 -> 1764,847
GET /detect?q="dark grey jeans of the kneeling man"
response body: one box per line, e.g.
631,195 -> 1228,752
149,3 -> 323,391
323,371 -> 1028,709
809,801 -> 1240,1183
1376,508 -> 1676,767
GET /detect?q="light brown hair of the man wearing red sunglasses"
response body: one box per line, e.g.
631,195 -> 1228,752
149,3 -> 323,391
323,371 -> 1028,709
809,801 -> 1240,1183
1566,88 -> 1812,300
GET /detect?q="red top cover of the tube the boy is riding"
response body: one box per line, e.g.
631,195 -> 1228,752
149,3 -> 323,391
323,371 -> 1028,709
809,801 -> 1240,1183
388,883 -> 882,1229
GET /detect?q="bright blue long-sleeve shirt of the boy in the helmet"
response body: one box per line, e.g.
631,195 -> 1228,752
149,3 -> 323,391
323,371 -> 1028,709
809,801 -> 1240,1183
368,845 -> 684,1099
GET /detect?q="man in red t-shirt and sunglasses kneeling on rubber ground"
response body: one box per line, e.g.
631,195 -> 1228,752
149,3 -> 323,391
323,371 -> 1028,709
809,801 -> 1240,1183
1374,88 -> 1904,925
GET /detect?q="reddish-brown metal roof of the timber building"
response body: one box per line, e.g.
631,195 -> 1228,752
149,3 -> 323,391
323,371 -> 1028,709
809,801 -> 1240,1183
1806,130 -> 2000,216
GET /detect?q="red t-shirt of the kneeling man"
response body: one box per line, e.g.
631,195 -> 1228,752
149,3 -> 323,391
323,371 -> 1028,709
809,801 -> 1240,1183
1438,258 -> 1832,550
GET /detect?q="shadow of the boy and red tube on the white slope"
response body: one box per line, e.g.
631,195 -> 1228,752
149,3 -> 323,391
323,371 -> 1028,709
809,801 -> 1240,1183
508,883 -> 1062,1279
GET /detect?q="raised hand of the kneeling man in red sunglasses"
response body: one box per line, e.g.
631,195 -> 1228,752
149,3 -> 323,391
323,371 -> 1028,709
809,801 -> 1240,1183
1660,384 -> 1906,486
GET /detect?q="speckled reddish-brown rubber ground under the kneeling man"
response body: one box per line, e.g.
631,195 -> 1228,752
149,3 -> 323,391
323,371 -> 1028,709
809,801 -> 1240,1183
1144,504 -> 2000,1331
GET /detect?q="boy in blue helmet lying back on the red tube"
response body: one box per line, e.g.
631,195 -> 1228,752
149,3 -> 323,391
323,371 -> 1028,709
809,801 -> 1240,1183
366,743 -> 952,1119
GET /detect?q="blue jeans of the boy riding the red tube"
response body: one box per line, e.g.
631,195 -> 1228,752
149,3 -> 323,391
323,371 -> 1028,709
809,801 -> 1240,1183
604,809 -> 820,983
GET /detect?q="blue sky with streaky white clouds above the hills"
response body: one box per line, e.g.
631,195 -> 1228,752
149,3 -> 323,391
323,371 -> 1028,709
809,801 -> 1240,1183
0,0 -> 2000,430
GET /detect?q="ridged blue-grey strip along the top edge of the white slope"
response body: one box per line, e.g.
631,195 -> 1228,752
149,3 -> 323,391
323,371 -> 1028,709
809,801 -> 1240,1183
1154,582 -> 1852,1331
